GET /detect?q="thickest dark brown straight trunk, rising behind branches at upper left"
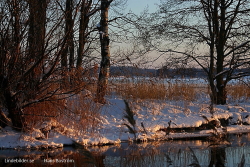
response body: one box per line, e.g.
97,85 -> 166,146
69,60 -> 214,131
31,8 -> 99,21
27,0 -> 48,94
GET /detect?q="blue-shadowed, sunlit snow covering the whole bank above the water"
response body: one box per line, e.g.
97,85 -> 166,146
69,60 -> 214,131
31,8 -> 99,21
0,92 -> 250,149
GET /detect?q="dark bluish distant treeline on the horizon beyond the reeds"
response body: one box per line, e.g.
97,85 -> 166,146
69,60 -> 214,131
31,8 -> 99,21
110,66 -> 250,78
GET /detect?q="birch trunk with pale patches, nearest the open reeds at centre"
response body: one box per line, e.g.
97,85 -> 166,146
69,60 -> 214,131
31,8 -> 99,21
96,0 -> 112,103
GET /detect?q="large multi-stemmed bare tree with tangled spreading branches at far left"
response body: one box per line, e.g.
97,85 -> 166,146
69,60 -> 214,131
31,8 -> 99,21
0,0 -> 89,130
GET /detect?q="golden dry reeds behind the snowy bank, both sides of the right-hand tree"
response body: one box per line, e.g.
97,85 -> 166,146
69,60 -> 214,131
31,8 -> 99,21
113,76 -> 250,101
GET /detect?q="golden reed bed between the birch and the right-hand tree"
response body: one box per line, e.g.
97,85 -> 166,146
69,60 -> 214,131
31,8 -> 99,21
115,80 -> 197,101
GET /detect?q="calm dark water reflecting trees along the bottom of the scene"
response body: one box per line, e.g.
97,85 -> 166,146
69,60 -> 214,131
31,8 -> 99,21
0,134 -> 250,167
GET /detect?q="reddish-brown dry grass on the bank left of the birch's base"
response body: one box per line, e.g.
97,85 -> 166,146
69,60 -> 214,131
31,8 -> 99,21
24,92 -> 100,135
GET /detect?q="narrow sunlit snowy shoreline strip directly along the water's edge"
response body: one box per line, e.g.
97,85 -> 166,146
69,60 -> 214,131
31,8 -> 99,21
0,125 -> 250,150
